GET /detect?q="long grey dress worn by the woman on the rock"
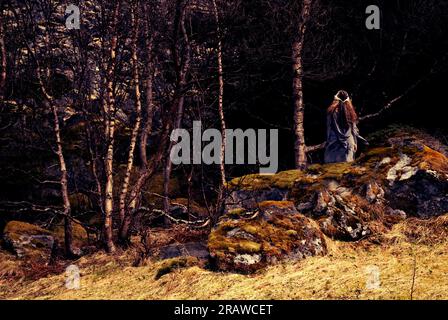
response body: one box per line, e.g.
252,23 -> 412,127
324,104 -> 367,163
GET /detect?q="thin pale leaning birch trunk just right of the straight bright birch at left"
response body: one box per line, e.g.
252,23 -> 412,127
119,7 -> 142,240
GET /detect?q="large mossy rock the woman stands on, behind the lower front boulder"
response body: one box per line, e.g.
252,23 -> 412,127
226,127 -> 448,246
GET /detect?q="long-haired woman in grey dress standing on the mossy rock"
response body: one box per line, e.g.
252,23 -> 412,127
324,90 -> 368,163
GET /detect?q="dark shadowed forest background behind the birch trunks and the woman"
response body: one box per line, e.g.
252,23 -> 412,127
0,0 -> 448,255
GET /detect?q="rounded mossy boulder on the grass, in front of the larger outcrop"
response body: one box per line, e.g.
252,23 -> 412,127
208,201 -> 327,272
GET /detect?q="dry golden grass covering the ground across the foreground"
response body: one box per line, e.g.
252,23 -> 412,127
0,216 -> 448,299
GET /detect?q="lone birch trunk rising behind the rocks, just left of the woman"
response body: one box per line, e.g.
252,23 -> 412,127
292,0 -> 312,169
